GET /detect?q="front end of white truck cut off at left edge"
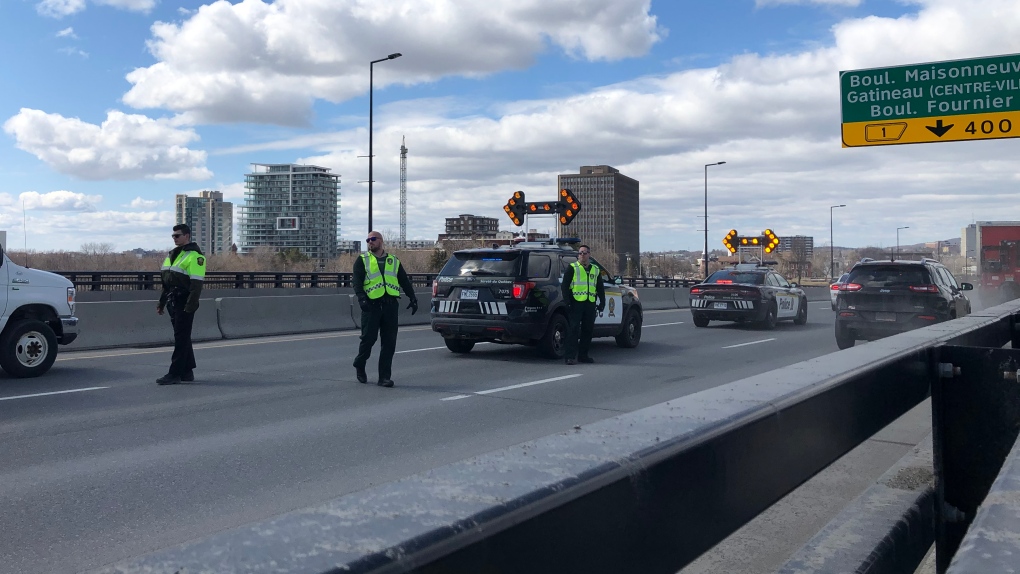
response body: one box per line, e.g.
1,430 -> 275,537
0,246 -> 78,377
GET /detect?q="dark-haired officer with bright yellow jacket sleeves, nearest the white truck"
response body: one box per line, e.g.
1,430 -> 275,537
156,223 -> 205,384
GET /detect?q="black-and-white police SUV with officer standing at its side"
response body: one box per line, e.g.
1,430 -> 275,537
431,240 -> 643,359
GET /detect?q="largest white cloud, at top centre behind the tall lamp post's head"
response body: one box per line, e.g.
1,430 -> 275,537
123,0 -> 662,124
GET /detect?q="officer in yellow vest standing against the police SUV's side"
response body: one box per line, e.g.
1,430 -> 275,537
560,245 -> 606,365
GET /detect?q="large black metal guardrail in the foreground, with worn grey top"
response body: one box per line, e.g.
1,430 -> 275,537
100,302 -> 1020,574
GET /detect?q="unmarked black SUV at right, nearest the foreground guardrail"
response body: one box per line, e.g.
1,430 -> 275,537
835,259 -> 974,349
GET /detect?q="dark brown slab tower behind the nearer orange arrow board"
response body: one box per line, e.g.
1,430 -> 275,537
558,165 -> 641,273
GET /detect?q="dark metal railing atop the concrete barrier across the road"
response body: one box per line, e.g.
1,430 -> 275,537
56,271 -> 699,291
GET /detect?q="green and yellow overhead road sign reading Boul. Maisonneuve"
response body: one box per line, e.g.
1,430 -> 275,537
839,54 -> 1020,148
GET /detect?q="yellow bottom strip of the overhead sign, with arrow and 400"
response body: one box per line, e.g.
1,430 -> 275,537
842,111 -> 1020,148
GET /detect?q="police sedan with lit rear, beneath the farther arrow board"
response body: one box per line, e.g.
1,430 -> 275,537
691,263 -> 808,329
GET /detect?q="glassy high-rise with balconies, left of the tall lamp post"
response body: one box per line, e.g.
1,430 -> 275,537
238,163 -> 340,261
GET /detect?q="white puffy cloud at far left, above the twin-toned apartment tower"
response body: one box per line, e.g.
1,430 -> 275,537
4,108 -> 212,179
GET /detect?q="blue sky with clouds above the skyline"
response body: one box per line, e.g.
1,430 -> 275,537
0,0 -> 1020,255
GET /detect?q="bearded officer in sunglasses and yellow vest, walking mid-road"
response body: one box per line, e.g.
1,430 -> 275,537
353,231 -> 418,386
